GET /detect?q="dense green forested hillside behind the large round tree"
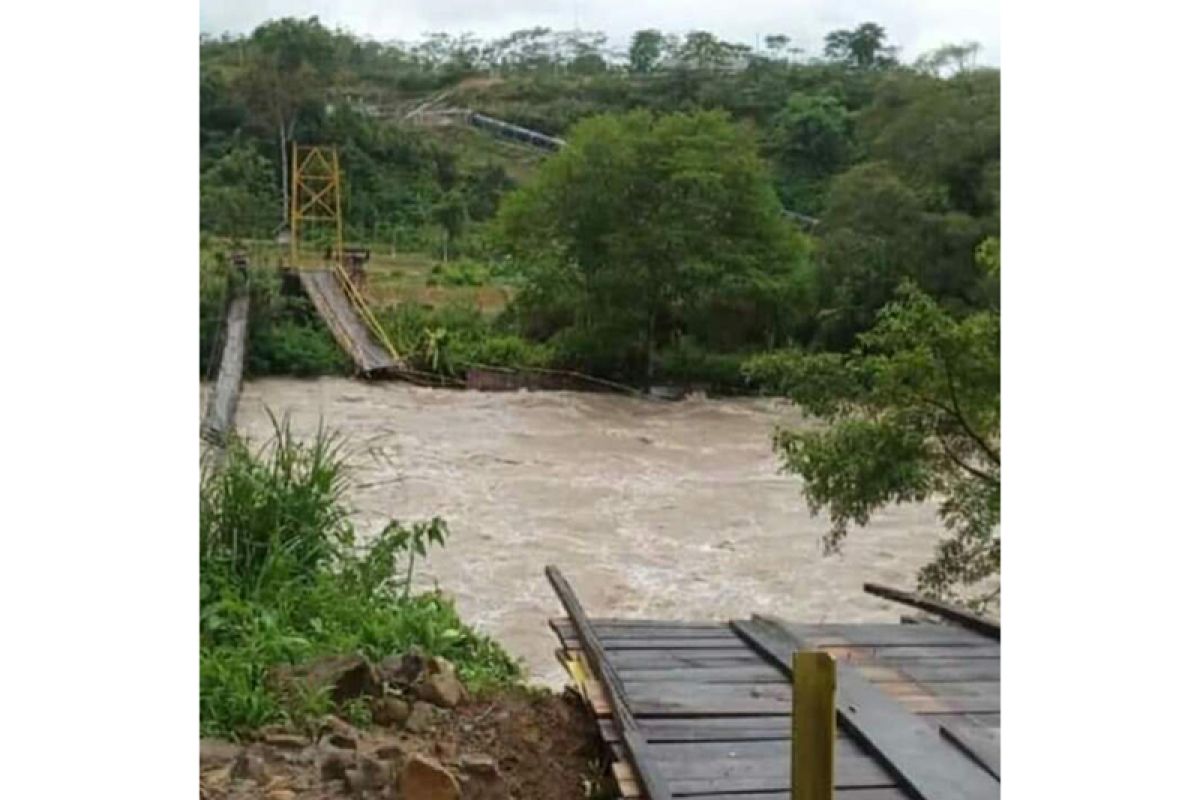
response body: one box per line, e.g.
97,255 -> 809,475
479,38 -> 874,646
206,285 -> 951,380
200,18 -> 1000,355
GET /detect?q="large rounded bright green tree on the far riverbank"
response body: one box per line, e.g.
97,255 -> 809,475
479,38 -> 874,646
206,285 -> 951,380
498,110 -> 805,380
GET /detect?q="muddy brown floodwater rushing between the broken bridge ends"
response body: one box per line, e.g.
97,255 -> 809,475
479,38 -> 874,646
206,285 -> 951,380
202,378 -> 955,685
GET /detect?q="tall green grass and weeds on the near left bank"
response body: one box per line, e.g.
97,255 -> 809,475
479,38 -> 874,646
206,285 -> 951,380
200,419 -> 520,736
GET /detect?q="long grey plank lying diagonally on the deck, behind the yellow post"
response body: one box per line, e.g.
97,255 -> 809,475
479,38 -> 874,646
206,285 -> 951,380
733,616 -> 1000,800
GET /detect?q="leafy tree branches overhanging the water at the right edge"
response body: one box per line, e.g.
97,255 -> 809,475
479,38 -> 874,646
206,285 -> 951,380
749,239 -> 1000,607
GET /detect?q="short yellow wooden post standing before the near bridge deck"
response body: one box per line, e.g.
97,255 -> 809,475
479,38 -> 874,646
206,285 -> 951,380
792,652 -> 838,800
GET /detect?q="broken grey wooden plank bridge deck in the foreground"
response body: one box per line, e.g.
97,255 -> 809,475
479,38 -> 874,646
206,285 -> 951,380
551,609 -> 1000,800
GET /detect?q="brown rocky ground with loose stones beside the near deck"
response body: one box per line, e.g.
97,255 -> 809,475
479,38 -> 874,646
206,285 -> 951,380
200,655 -> 610,800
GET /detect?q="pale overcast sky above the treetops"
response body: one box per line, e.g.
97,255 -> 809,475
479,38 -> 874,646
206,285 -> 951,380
200,0 -> 1000,65
